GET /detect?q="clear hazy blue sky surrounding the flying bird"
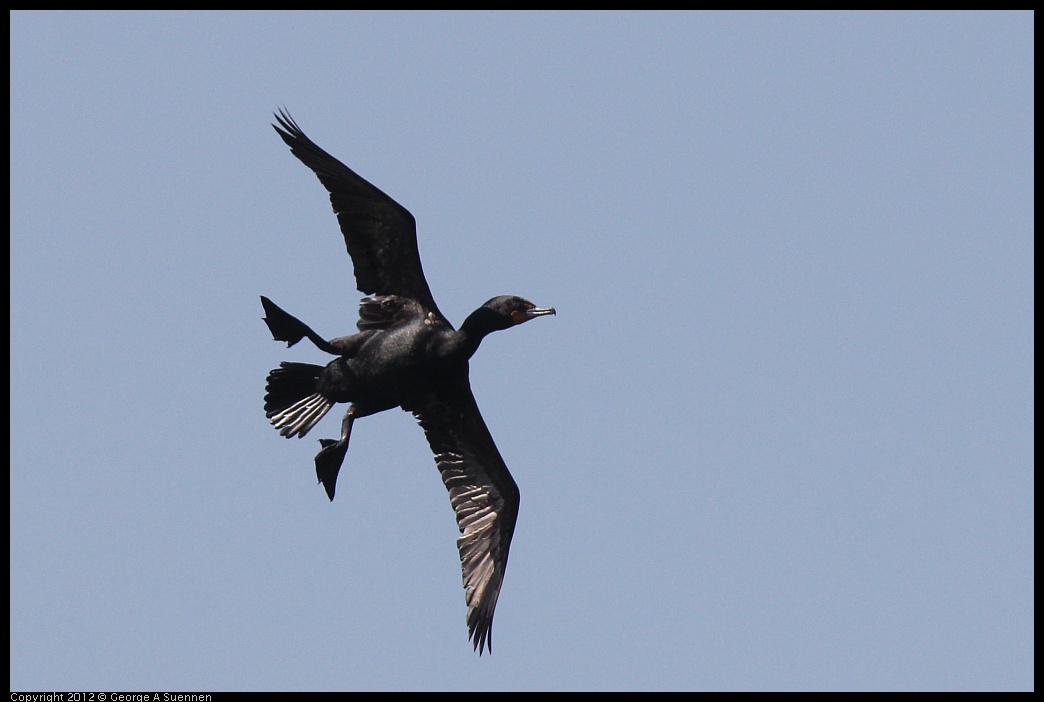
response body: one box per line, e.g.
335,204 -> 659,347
10,13 -> 1034,692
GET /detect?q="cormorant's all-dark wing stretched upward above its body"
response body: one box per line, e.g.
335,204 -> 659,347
272,110 -> 443,318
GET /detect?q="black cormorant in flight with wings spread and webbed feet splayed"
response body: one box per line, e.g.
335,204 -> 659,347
261,110 -> 555,655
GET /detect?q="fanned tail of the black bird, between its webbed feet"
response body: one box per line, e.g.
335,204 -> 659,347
264,362 -> 334,439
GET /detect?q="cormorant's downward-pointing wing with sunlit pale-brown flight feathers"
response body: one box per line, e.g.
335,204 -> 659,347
408,381 -> 519,654
